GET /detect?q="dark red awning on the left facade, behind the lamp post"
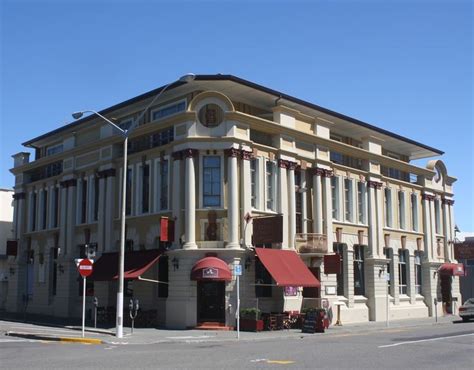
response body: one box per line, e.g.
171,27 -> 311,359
91,249 -> 162,281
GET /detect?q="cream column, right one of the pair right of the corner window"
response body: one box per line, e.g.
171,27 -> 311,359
240,148 -> 253,248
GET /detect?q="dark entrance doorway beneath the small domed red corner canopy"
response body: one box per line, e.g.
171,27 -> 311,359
197,281 -> 225,323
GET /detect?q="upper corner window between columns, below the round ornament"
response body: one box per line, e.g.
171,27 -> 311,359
203,156 -> 221,207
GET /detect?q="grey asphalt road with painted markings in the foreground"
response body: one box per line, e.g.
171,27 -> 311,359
0,322 -> 474,370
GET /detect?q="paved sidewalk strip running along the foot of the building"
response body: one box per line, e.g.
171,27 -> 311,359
0,316 -> 459,345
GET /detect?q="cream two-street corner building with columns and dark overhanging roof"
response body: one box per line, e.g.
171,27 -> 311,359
6,75 -> 460,328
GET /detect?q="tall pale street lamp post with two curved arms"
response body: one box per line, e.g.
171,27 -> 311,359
72,73 -> 196,338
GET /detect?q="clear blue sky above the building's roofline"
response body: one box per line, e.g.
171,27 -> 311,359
0,0 -> 474,231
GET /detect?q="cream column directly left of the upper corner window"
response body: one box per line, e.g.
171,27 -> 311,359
183,149 -> 199,249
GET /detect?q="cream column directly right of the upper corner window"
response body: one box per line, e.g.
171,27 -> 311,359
224,148 -> 240,248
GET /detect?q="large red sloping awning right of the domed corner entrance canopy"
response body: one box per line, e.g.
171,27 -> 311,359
255,248 -> 321,288
